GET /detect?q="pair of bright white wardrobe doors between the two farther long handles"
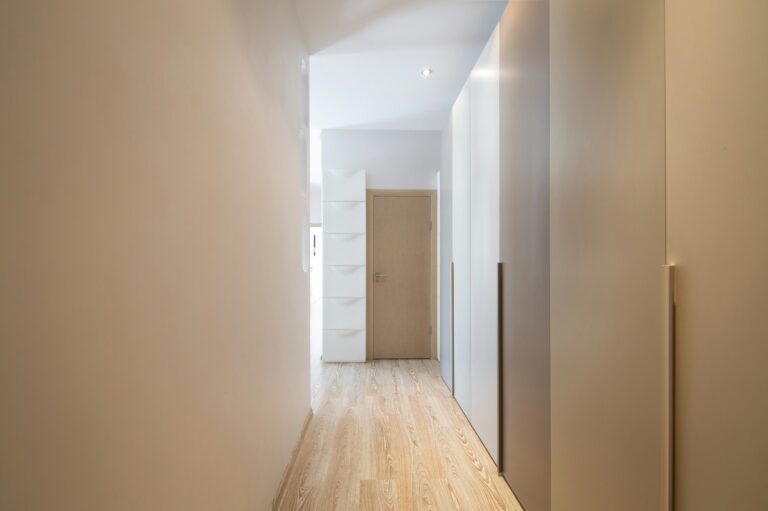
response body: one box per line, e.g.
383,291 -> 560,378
451,30 -> 499,463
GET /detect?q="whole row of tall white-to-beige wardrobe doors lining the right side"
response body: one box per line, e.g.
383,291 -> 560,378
452,0 -> 768,511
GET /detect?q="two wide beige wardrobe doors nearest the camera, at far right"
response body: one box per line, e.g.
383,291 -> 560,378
550,0 -> 768,511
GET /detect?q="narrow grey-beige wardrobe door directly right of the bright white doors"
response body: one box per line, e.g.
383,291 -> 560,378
499,0 -> 550,511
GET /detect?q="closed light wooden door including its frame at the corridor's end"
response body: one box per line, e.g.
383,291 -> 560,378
368,192 -> 434,359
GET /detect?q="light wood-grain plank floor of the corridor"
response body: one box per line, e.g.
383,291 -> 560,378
280,360 -> 522,511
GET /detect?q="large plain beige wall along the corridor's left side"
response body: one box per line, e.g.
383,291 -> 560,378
0,0 -> 309,510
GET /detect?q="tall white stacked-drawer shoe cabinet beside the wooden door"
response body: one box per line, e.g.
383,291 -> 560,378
323,170 -> 366,362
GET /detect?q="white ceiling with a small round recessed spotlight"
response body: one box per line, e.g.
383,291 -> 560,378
296,0 -> 507,130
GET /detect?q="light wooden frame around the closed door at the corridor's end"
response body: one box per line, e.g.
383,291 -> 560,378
365,188 -> 438,360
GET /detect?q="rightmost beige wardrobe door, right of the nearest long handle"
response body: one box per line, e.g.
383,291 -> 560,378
667,0 -> 768,511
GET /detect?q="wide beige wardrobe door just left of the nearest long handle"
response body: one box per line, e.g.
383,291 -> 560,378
550,0 -> 665,511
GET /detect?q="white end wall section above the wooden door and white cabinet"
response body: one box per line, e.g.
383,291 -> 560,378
322,130 -> 442,190
